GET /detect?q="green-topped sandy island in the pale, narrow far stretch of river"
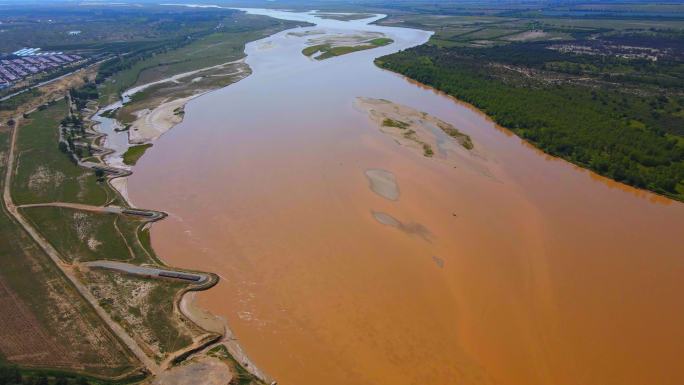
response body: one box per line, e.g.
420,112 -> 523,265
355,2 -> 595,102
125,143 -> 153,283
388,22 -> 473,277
302,32 -> 394,60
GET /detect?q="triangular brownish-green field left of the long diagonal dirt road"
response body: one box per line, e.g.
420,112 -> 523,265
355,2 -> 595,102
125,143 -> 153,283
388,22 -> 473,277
0,125 -> 137,376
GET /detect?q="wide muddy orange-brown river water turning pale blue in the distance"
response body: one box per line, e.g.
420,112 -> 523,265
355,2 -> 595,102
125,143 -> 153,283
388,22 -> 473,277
128,10 -> 684,385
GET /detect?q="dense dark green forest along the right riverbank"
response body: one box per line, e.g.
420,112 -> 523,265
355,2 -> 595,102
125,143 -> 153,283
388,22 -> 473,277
376,43 -> 684,200
